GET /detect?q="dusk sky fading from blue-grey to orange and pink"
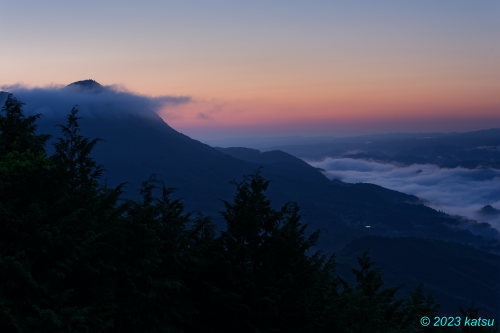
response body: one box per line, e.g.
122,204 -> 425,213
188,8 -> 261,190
0,0 -> 500,139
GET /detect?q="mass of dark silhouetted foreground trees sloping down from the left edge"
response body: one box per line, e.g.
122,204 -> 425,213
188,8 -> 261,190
0,96 -> 492,332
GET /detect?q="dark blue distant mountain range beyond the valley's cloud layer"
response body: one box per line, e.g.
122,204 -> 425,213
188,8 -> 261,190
272,128 -> 500,169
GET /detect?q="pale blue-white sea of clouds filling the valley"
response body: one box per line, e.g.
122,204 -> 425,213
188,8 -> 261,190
309,158 -> 500,229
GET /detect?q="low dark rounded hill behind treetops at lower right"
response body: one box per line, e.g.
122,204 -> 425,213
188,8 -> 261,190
337,236 -> 500,316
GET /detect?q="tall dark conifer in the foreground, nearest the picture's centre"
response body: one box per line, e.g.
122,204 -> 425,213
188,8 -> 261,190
217,173 -> 333,332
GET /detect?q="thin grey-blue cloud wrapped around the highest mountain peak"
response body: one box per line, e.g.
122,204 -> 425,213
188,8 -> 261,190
0,85 -> 191,117
